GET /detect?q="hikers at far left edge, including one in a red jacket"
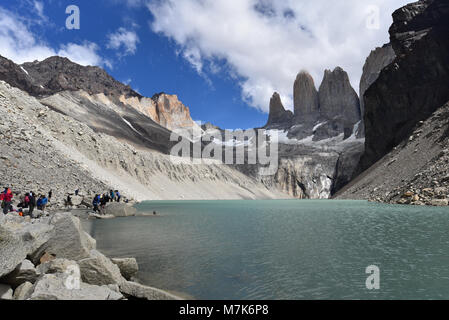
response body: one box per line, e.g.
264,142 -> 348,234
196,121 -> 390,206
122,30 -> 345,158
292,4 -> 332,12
0,187 -> 53,217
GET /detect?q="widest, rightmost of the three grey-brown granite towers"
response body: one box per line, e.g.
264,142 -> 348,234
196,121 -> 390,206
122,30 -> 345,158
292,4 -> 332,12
318,67 -> 360,126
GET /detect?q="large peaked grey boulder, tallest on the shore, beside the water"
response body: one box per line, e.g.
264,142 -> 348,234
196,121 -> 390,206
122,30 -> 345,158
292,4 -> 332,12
33,213 -> 96,261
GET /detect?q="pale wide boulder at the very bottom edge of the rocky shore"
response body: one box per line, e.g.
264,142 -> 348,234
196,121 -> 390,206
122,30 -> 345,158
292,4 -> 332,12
30,273 -> 123,300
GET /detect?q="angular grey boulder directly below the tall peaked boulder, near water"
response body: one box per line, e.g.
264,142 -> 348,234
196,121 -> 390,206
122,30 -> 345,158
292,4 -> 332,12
79,250 -> 125,285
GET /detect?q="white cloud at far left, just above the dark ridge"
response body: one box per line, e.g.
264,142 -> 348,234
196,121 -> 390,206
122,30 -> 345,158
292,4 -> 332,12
0,7 -> 108,67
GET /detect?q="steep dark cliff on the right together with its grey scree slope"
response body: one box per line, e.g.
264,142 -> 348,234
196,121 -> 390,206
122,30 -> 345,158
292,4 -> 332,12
337,0 -> 449,205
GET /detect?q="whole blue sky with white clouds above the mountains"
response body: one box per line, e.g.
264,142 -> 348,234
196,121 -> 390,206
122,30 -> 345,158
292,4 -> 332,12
0,0 -> 408,129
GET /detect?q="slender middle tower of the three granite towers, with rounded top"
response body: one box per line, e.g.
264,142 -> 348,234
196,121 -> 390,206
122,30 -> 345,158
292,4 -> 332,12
293,71 -> 319,122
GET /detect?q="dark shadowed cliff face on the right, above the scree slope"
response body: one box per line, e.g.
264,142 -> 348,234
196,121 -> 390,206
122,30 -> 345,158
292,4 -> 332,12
359,0 -> 449,172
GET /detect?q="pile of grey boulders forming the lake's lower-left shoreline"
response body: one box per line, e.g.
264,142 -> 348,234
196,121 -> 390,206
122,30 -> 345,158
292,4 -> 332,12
0,205 -> 180,300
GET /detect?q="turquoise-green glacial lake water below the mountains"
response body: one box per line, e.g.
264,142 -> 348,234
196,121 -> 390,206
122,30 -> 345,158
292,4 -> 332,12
86,200 -> 449,300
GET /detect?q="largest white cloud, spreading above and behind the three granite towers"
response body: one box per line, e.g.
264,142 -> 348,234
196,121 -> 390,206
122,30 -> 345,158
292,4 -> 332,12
148,0 -> 410,111
